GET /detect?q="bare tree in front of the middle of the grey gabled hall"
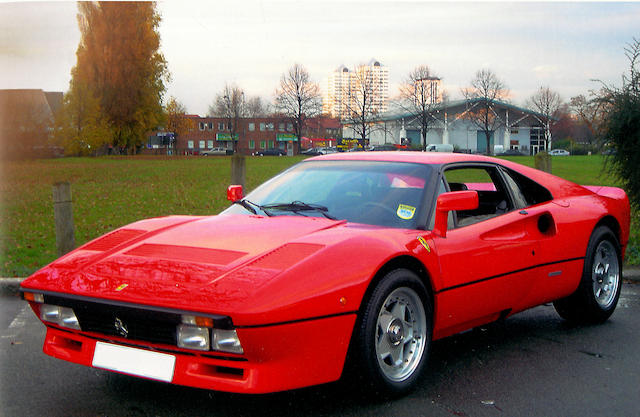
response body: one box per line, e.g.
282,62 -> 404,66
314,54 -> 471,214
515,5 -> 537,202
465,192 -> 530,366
462,69 -> 509,155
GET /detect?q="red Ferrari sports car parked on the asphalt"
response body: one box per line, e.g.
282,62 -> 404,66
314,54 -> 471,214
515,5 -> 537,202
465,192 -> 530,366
21,152 -> 629,394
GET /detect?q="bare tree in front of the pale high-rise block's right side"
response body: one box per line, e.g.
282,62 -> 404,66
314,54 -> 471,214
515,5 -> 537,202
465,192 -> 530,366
342,66 -> 380,149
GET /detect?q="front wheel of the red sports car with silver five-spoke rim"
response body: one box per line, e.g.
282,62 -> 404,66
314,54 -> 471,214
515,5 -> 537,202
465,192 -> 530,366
355,269 -> 432,396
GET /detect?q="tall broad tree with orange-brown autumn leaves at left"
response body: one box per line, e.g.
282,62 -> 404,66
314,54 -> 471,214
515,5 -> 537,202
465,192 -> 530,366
57,2 -> 169,153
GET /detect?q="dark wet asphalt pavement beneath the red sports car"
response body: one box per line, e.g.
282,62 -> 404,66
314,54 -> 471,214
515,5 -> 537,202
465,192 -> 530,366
0,284 -> 640,417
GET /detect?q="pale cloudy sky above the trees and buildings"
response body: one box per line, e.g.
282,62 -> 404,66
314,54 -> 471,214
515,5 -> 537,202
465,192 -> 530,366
0,0 -> 640,115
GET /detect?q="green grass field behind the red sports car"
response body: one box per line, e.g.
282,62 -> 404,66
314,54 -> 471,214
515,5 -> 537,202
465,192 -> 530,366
0,155 -> 640,276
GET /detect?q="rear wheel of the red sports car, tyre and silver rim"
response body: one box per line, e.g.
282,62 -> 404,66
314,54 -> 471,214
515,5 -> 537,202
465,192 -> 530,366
553,226 -> 622,324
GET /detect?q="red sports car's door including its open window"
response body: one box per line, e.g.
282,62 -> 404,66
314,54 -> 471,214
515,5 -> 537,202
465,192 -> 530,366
434,164 -> 537,334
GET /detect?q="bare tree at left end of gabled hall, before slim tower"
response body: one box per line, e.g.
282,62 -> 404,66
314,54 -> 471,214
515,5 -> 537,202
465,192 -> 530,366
398,65 -> 442,151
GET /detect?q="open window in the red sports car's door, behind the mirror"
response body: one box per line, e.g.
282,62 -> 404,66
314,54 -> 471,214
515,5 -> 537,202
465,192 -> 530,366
445,166 -> 516,227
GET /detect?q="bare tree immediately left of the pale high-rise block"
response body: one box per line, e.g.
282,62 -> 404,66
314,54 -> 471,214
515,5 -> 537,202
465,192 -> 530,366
275,64 -> 322,153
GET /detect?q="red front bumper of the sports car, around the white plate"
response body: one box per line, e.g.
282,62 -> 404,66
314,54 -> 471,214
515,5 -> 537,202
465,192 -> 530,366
38,313 -> 356,393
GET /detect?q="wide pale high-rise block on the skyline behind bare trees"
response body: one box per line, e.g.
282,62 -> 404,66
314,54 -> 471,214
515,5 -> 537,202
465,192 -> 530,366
324,59 -> 389,119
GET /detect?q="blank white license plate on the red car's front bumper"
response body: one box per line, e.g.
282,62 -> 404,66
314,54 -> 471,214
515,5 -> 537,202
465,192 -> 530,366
91,342 -> 176,382
